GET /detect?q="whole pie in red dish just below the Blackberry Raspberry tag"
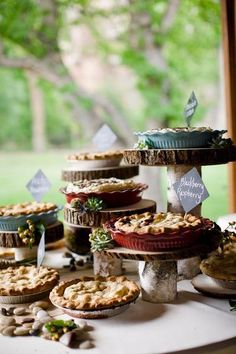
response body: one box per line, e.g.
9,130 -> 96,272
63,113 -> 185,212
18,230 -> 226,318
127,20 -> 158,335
104,212 -> 214,252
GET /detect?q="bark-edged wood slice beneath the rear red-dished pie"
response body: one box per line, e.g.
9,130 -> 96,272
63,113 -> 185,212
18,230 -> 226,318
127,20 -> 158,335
64,199 -> 156,227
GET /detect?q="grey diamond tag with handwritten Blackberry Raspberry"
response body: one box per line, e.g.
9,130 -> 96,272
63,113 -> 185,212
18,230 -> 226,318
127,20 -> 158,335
173,167 -> 209,213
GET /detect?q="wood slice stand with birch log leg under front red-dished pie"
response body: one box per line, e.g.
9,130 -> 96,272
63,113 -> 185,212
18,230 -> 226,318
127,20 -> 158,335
104,237 -> 217,303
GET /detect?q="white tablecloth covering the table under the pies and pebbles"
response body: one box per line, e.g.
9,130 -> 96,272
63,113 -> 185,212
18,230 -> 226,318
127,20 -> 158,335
0,251 -> 236,354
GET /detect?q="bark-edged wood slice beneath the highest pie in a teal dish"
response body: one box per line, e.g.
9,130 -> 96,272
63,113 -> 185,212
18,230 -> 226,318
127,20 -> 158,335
124,145 -> 236,166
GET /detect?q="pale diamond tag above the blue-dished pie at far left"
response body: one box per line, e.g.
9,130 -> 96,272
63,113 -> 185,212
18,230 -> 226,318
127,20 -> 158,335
26,169 -> 51,202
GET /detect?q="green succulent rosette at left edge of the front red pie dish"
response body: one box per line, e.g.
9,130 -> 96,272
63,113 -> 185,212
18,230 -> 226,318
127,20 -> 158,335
89,228 -> 114,252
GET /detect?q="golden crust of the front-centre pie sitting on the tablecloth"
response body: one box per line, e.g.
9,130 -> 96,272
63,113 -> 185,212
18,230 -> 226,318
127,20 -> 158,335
49,276 -> 140,310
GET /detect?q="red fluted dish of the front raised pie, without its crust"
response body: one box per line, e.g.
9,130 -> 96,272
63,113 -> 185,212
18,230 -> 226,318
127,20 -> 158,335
104,218 -> 214,252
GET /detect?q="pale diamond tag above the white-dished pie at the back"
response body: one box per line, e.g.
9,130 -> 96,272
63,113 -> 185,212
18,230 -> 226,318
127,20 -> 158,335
93,124 -> 117,151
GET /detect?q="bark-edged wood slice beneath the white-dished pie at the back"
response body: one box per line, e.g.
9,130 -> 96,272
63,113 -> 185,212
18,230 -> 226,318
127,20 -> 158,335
61,165 -> 139,182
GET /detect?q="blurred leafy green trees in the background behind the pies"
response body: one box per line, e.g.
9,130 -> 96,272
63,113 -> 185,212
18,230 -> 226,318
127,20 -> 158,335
0,0 -> 220,150
